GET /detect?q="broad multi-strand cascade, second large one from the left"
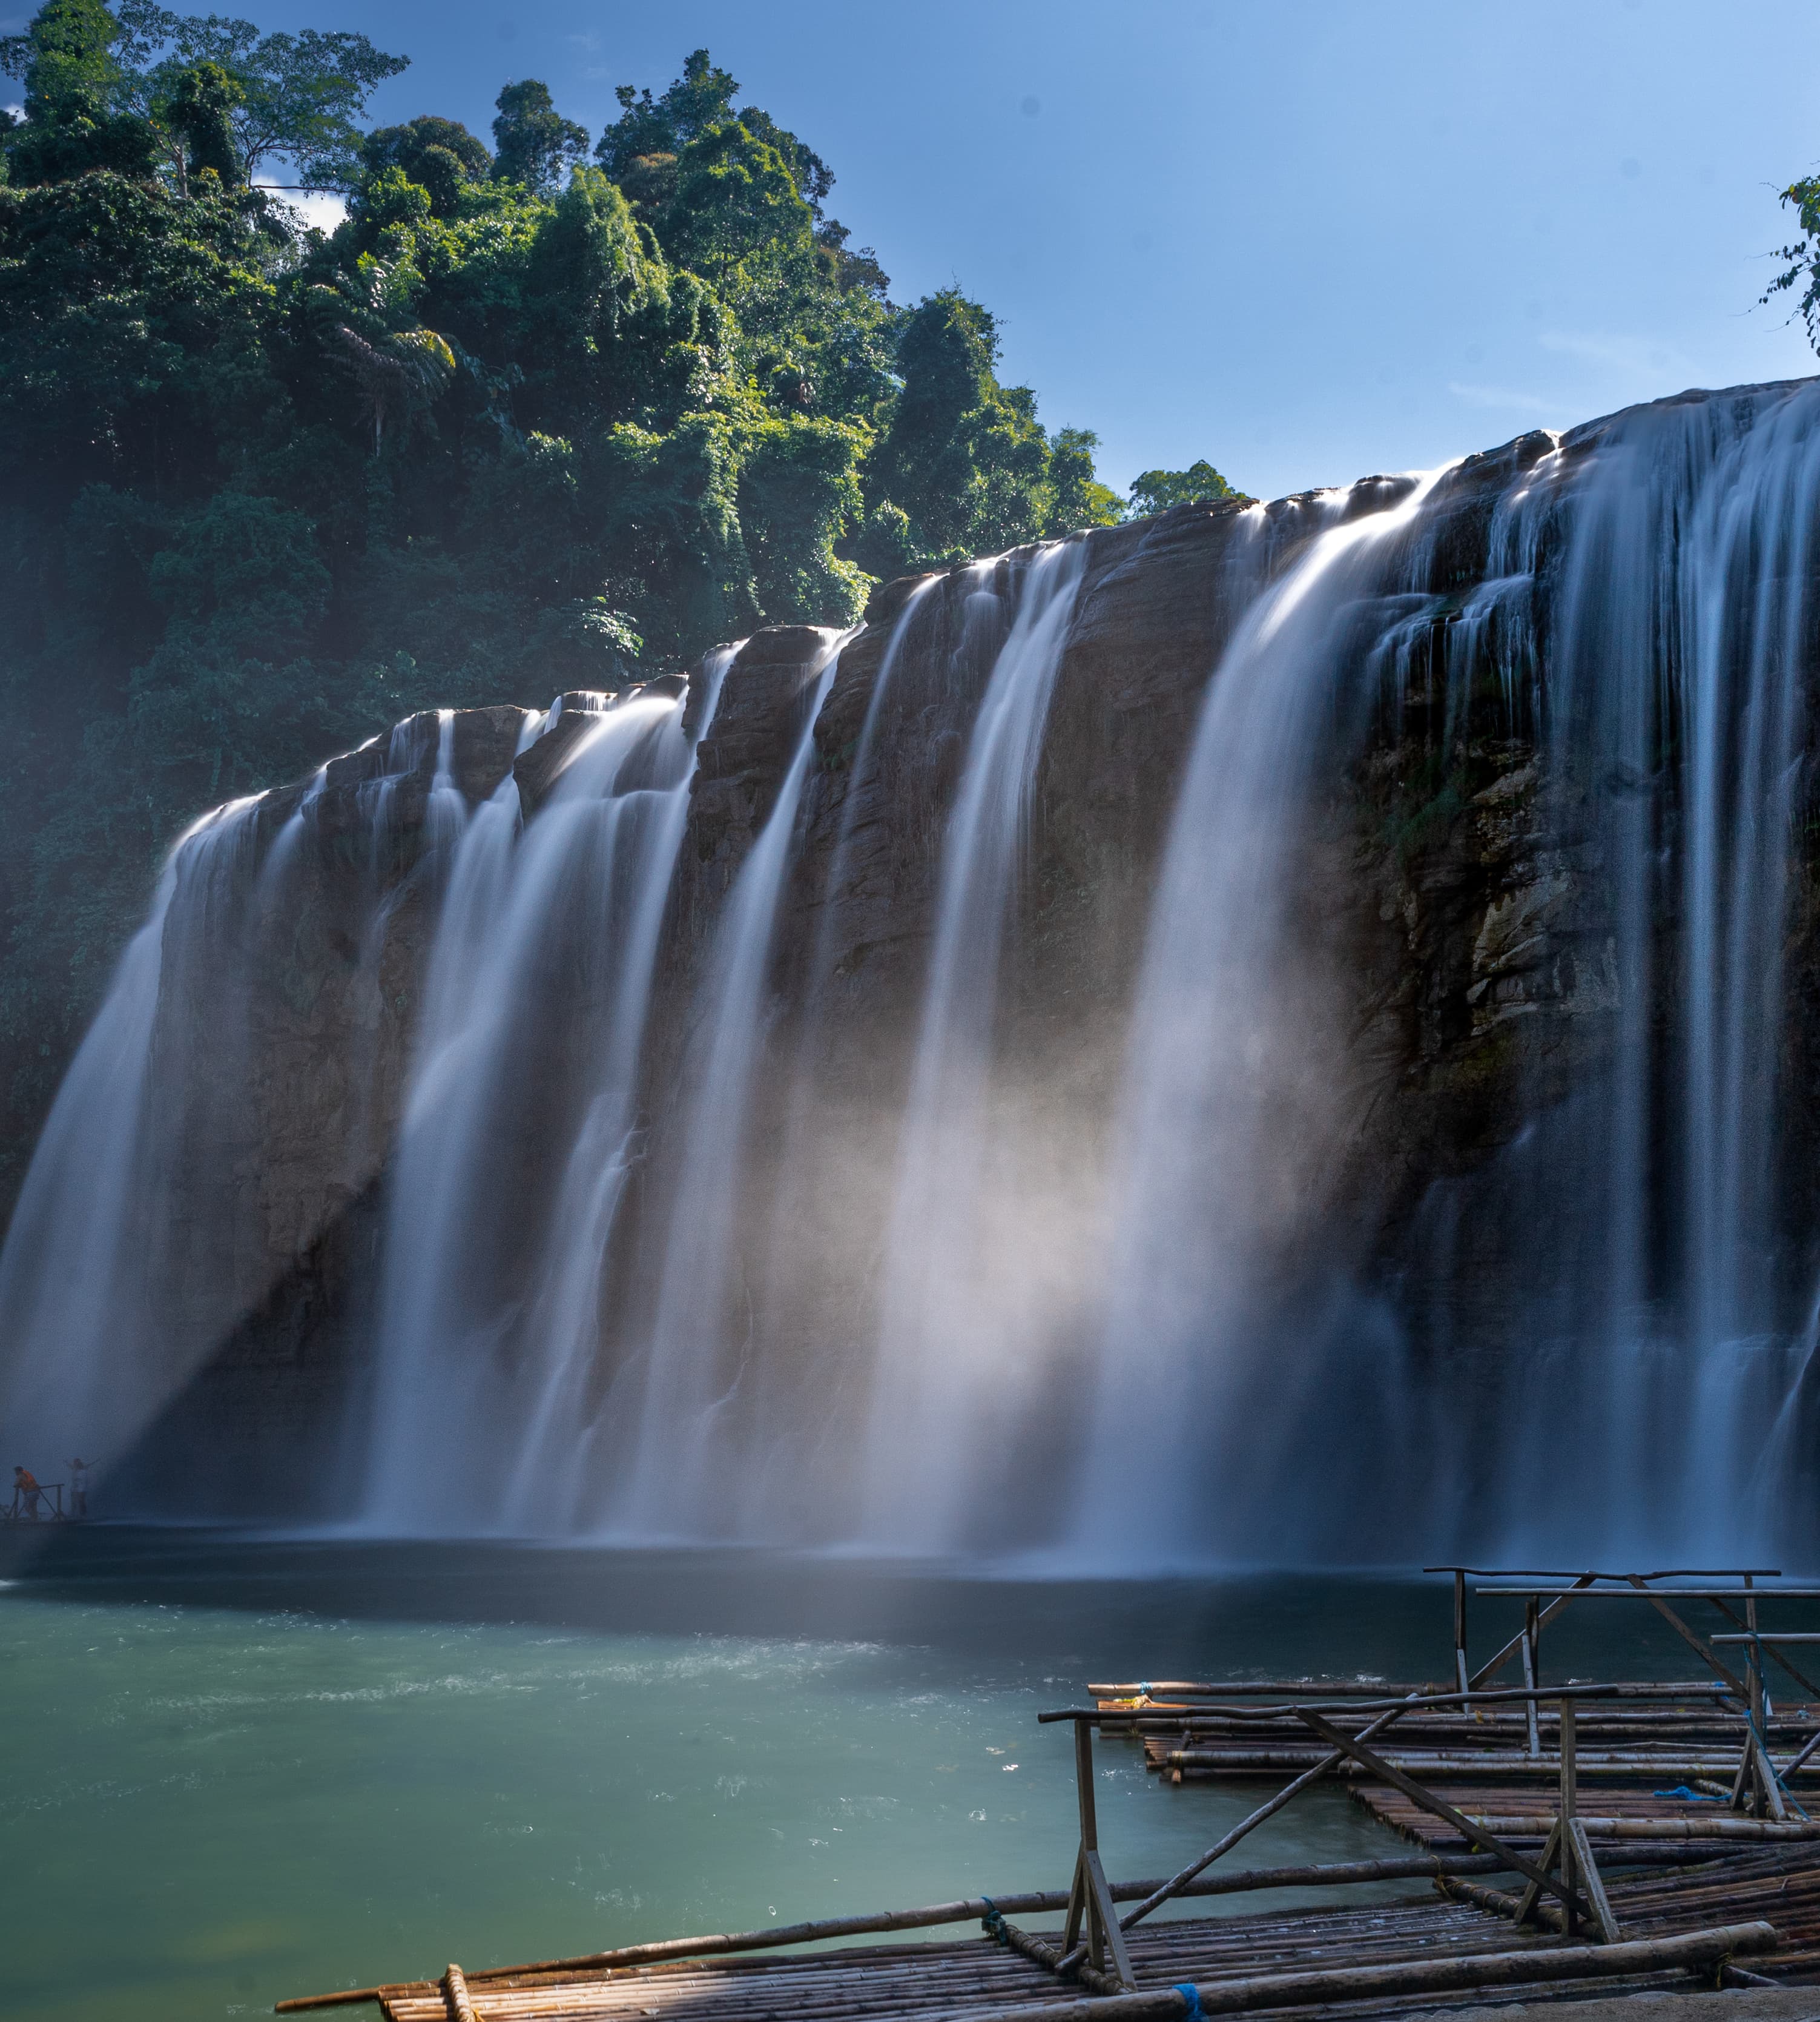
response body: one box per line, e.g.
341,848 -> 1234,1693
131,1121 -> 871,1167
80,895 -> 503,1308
364,663 -> 736,1531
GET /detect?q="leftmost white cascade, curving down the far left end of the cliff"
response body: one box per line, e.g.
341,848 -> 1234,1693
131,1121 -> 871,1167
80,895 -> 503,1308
0,712 -> 487,1504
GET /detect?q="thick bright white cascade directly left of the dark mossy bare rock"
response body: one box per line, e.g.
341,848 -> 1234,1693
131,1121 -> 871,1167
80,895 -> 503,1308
1076,471 -> 1442,1555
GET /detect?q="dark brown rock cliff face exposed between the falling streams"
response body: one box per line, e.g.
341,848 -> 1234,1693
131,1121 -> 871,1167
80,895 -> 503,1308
71,382 -> 1820,1508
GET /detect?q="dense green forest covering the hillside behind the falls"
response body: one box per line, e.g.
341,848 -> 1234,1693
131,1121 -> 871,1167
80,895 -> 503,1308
0,0 -> 1225,1181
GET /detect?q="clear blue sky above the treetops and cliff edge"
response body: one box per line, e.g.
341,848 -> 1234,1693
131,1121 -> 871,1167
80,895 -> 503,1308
14,0 -> 1820,495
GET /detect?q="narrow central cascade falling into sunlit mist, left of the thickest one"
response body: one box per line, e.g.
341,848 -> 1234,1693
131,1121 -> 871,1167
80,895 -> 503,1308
862,540 -> 1086,1551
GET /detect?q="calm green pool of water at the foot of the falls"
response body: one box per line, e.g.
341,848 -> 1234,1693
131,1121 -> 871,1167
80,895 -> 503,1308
0,1531 -> 1715,2022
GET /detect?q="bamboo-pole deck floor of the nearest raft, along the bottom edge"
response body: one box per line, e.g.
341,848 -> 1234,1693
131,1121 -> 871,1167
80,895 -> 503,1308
355,1850 -> 1820,2022
